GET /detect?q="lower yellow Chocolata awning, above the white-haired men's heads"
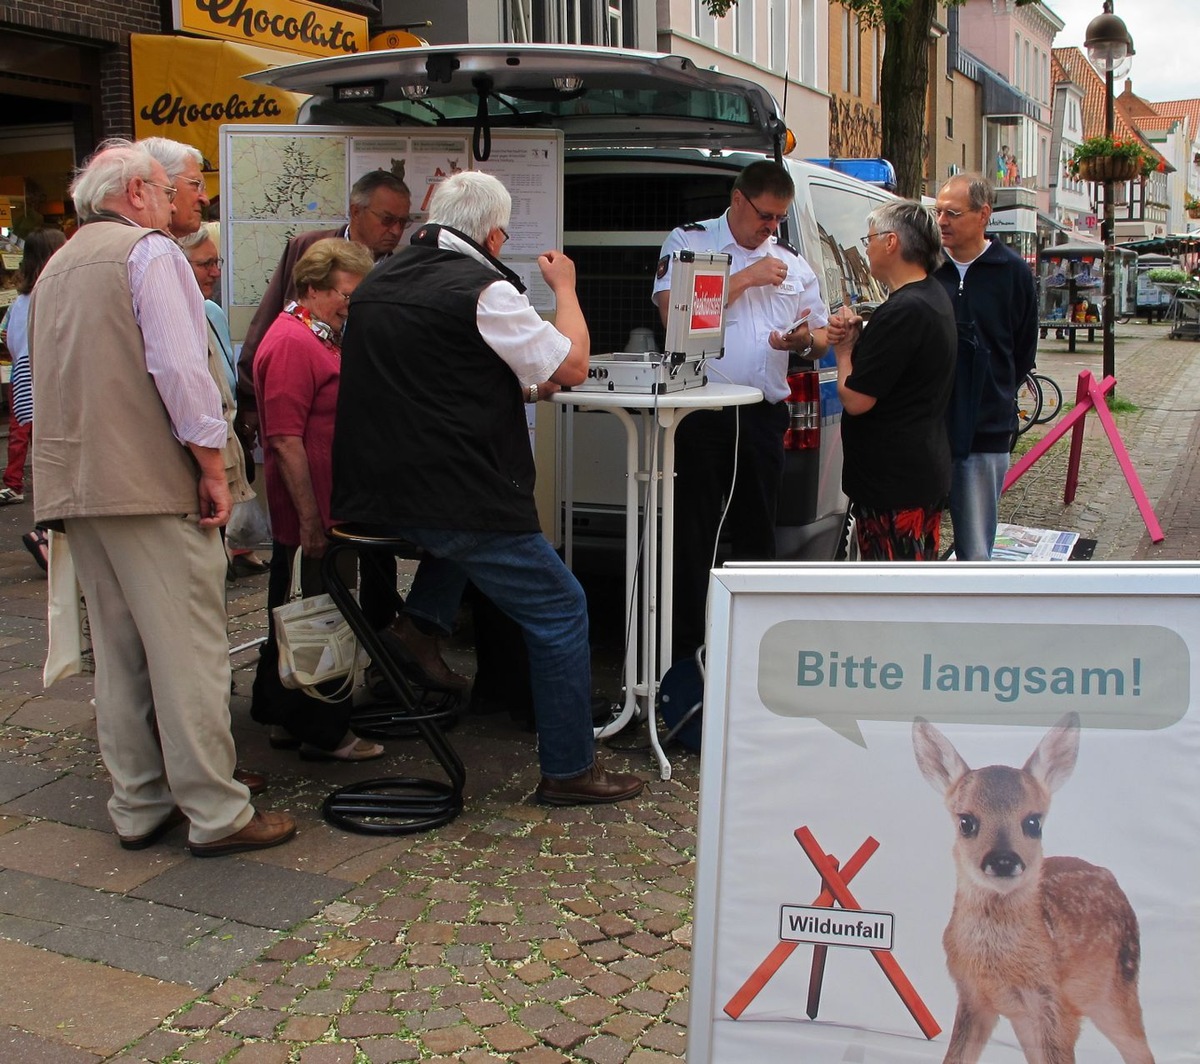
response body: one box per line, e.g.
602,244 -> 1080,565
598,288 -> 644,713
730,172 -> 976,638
131,34 -> 307,198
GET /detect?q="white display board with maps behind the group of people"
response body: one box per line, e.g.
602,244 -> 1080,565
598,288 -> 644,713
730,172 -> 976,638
221,125 -> 563,341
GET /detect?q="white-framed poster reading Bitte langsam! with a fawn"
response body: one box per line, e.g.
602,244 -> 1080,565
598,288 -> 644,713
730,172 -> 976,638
688,563 -> 1200,1064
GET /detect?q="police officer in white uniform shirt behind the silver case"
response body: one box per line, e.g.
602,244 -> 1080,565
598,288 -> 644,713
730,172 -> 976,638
653,161 -> 829,661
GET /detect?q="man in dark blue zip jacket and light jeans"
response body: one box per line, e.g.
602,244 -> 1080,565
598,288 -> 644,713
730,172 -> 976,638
935,174 -> 1038,561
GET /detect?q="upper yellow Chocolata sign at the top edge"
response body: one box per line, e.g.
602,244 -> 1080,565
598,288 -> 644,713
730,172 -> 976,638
172,0 -> 368,56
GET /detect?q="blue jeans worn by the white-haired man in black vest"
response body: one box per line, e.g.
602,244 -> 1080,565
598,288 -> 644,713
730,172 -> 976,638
396,528 -> 595,780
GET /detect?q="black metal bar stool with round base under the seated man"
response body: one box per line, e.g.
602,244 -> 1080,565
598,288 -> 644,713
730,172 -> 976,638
322,524 -> 467,835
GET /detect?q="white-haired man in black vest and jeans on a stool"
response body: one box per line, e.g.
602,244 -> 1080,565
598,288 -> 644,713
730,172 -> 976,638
332,172 -> 642,805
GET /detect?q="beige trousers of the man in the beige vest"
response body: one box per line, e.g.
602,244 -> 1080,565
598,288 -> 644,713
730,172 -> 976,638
66,515 -> 254,842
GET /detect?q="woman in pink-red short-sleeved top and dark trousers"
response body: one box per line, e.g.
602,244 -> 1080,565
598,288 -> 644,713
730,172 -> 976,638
250,238 -> 384,761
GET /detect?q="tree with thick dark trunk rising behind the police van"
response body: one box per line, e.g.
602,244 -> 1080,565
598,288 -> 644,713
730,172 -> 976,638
706,0 -> 1036,198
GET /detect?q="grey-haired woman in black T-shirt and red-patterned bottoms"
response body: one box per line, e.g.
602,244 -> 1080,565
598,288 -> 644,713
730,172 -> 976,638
829,200 -> 958,561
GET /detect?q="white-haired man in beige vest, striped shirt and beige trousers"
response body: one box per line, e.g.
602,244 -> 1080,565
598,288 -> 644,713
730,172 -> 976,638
30,142 -> 295,856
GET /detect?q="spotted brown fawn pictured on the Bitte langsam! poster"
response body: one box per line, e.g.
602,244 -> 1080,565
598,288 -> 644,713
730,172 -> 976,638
912,713 -> 1154,1064
